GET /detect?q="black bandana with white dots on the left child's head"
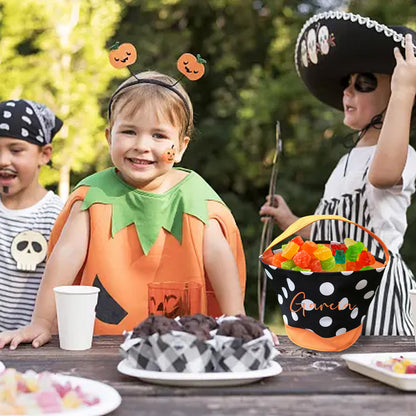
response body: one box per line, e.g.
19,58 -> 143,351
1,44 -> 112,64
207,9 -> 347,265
0,100 -> 63,146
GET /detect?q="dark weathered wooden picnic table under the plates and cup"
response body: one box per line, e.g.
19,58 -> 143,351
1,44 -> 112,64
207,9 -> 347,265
0,336 -> 416,416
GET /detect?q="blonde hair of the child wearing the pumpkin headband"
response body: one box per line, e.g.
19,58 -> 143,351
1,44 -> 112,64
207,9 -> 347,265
109,71 -> 193,140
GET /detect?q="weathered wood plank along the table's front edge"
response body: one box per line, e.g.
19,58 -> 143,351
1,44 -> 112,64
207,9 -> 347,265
105,394 -> 415,416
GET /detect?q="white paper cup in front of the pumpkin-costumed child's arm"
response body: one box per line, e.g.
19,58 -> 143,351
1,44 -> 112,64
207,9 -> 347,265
53,286 -> 100,350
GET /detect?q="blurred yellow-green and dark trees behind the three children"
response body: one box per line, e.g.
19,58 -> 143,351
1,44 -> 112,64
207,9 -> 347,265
0,0 -> 416,330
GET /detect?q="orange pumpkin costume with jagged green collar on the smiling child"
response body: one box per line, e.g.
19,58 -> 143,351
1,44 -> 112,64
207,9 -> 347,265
49,168 -> 246,334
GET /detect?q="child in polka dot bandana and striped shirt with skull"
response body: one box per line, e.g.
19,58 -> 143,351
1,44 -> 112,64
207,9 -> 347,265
0,100 -> 63,331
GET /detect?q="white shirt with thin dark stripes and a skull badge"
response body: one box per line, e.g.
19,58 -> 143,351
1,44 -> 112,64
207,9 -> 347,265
0,191 -> 63,331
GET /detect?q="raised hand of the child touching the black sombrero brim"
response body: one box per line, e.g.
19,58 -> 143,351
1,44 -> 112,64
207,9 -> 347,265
391,34 -> 416,96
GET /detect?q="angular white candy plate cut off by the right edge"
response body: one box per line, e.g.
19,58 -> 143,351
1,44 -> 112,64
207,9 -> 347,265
341,351 -> 416,391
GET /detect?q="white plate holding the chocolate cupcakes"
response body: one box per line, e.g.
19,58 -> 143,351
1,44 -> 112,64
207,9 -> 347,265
117,359 -> 282,387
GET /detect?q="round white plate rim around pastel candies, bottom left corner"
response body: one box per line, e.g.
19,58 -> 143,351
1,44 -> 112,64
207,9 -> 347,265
0,368 -> 121,416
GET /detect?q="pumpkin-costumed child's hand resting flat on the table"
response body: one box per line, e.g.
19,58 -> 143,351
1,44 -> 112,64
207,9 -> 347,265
0,323 -> 51,350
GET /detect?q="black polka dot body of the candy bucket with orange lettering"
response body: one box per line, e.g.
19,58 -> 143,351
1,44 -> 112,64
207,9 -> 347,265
262,261 -> 384,338
